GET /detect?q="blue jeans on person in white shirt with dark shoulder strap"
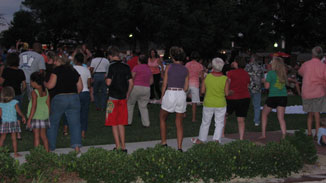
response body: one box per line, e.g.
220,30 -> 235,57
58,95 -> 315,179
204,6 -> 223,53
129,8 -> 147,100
93,73 -> 107,109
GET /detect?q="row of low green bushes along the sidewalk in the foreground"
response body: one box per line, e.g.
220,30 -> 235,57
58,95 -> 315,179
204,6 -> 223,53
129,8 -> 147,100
0,131 -> 316,182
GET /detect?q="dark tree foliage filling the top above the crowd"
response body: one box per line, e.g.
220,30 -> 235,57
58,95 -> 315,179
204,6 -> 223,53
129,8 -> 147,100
0,0 -> 326,54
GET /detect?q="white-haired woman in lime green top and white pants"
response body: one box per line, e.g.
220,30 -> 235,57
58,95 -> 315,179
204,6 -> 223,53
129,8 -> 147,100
191,58 -> 229,144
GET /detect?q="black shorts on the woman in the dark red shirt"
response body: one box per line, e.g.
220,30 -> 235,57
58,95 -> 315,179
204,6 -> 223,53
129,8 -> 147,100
226,98 -> 250,117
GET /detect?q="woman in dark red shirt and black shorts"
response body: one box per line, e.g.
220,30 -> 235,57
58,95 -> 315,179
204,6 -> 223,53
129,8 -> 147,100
222,57 -> 250,140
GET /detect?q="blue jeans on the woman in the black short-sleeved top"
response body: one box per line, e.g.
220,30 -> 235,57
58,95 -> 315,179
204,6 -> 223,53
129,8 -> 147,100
47,94 -> 81,151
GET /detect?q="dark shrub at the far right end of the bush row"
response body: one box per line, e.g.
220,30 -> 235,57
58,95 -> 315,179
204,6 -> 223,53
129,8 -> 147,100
286,129 -> 318,164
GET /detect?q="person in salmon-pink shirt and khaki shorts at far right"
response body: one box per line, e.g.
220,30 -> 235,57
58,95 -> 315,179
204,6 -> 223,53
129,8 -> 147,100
298,46 -> 326,137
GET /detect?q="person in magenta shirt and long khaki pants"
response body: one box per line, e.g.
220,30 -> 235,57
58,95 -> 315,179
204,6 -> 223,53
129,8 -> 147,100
128,54 -> 153,128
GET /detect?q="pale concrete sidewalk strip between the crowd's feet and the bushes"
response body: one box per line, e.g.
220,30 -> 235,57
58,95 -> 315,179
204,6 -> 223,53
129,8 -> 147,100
11,136 -> 234,164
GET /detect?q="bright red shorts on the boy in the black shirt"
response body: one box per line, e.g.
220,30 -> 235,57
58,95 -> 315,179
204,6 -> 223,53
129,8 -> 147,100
105,99 -> 128,126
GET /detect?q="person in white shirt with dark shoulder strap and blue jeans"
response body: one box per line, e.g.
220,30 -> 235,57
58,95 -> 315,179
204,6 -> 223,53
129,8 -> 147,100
90,50 -> 110,111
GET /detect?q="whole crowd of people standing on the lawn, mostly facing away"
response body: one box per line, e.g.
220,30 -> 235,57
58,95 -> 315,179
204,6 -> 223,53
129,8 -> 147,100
0,43 -> 326,157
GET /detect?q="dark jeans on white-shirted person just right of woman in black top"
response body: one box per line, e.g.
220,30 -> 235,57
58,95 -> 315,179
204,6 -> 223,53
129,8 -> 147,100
79,91 -> 91,131
